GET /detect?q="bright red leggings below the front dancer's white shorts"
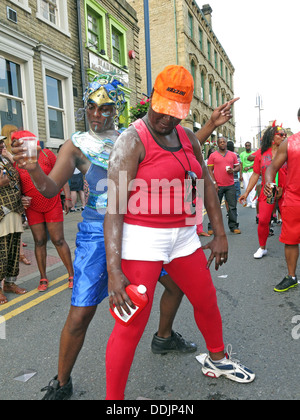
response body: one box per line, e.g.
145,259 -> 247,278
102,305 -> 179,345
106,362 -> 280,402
106,248 -> 224,400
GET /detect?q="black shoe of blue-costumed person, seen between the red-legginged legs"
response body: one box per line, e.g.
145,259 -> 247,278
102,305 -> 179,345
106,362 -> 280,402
151,331 -> 197,354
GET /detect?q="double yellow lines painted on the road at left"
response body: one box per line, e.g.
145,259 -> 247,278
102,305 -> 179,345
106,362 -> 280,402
0,275 -> 69,324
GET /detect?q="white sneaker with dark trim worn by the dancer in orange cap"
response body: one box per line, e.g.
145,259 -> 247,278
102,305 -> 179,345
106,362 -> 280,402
197,345 -> 255,384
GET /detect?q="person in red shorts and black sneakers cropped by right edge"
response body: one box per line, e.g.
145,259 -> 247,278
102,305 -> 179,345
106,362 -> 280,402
264,109 -> 300,292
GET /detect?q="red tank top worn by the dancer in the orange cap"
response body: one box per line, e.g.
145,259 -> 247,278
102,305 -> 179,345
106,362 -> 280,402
124,119 -> 202,228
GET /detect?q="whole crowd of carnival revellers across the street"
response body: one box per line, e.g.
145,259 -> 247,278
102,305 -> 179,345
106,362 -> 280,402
0,65 -> 300,400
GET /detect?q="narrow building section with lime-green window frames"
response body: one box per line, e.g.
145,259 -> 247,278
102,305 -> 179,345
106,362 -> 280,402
83,0 -> 141,130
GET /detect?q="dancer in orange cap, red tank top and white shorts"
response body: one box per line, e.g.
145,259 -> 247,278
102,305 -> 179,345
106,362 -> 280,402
104,65 -> 255,400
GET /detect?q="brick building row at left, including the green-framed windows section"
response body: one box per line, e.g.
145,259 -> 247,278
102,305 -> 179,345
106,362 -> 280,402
0,0 -> 141,148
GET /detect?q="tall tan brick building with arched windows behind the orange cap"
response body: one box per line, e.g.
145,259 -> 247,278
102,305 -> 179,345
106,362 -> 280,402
128,0 -> 235,140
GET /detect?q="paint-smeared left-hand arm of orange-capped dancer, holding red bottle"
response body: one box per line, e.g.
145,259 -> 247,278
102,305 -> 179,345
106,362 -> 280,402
104,127 -> 144,314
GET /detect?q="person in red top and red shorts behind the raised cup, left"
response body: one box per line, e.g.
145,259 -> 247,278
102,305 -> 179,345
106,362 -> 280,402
12,131 -> 74,292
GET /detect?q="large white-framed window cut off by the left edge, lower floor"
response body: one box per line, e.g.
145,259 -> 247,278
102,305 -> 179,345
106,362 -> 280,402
0,57 -> 24,128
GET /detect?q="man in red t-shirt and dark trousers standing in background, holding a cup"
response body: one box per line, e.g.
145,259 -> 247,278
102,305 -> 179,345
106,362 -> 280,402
207,137 -> 241,234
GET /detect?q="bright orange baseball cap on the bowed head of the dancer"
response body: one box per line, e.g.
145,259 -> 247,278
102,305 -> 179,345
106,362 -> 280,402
151,65 -> 194,120
